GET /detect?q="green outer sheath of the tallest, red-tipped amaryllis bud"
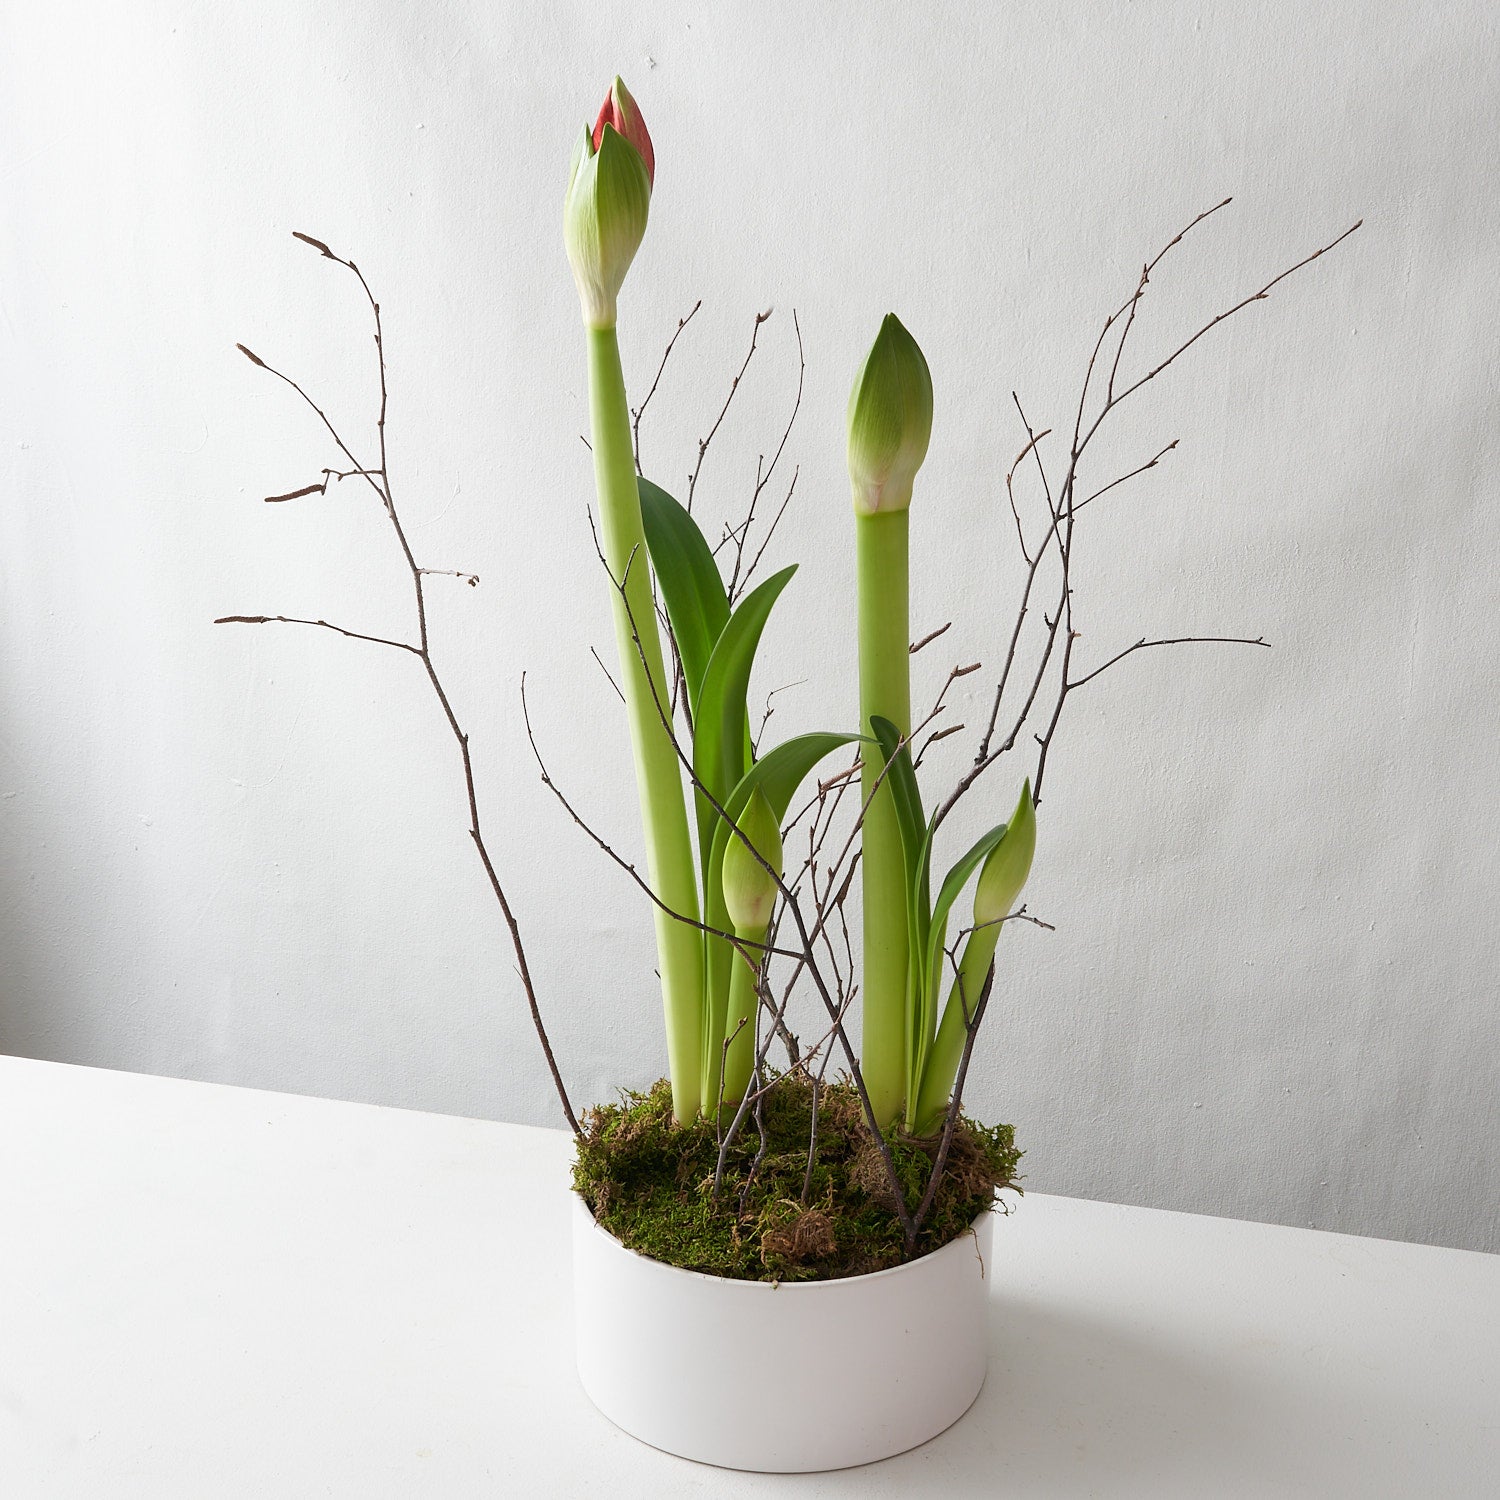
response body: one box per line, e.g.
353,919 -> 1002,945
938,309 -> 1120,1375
563,107 -> 651,329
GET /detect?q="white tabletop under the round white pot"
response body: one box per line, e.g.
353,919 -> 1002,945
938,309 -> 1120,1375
0,1059 -> 1500,1500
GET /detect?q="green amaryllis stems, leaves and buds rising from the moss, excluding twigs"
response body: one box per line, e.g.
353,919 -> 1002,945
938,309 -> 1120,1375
563,78 -> 1035,1131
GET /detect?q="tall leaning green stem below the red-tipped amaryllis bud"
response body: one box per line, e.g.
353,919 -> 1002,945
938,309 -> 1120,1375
588,327 -> 704,1124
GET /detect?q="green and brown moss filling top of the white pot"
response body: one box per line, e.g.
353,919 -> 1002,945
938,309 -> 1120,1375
573,1077 -> 1020,1281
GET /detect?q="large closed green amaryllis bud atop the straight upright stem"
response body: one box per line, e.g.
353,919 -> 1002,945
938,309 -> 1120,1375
849,312 -> 933,516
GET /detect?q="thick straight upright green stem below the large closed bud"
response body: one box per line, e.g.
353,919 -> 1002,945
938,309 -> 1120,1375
854,509 -> 912,1125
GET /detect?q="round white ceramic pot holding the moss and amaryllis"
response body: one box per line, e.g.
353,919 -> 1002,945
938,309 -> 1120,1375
573,1196 -> 993,1473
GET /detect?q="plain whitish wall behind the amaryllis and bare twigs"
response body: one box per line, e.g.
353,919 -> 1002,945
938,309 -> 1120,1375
0,0 -> 1500,1250
